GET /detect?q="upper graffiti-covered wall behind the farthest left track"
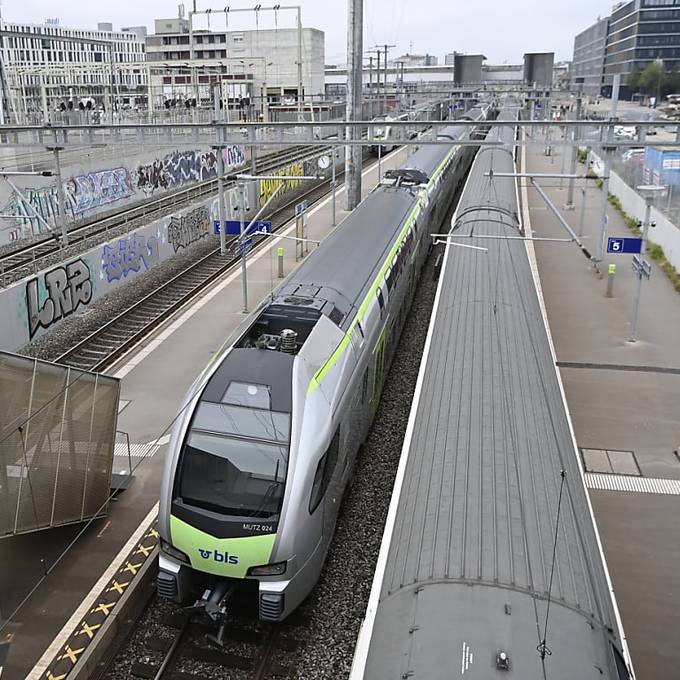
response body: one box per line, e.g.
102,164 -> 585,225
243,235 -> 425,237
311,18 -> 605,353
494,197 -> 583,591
0,144 -> 247,245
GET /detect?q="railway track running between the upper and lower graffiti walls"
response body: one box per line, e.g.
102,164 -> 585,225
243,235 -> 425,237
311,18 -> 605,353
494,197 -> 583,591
0,147 -> 330,286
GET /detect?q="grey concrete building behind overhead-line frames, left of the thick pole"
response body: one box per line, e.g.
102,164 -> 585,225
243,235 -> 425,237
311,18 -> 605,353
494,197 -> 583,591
146,18 -> 325,105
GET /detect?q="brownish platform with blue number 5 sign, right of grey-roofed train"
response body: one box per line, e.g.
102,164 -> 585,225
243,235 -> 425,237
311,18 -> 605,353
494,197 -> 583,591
521,130 -> 680,680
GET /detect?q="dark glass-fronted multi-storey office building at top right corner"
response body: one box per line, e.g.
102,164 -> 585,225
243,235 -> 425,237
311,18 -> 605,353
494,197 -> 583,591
572,0 -> 680,98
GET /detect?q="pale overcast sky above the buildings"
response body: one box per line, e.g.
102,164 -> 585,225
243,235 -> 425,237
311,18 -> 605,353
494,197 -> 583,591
2,0 -> 613,64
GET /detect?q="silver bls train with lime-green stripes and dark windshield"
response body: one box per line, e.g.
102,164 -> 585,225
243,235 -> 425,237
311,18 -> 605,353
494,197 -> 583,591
157,107 -> 488,621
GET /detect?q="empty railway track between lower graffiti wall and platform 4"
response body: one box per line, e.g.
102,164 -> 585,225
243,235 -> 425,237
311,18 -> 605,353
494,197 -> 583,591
55,157 -> 350,372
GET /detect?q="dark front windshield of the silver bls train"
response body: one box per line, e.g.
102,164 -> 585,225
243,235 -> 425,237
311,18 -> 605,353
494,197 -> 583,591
177,402 -> 290,518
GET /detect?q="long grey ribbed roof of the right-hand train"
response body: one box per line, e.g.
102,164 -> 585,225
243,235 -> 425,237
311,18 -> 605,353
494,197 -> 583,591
364,119 -> 627,680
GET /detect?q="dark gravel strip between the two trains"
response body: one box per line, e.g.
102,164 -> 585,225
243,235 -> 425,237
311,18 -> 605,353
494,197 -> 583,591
274,239 -> 441,680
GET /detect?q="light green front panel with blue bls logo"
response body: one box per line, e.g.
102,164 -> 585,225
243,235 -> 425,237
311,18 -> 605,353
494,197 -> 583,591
170,515 -> 276,578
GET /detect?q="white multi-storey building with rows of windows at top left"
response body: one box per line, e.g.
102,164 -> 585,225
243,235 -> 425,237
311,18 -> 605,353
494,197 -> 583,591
0,22 -> 146,122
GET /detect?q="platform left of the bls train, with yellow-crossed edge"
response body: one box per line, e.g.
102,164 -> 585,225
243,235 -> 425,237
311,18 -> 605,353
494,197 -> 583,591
0,149 -> 407,680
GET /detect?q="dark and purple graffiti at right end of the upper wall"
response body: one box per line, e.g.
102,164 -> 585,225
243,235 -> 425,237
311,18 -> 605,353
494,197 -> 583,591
136,144 -> 246,195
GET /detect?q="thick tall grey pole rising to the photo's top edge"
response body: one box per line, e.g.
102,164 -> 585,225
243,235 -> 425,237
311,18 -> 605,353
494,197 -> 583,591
345,0 -> 363,210
